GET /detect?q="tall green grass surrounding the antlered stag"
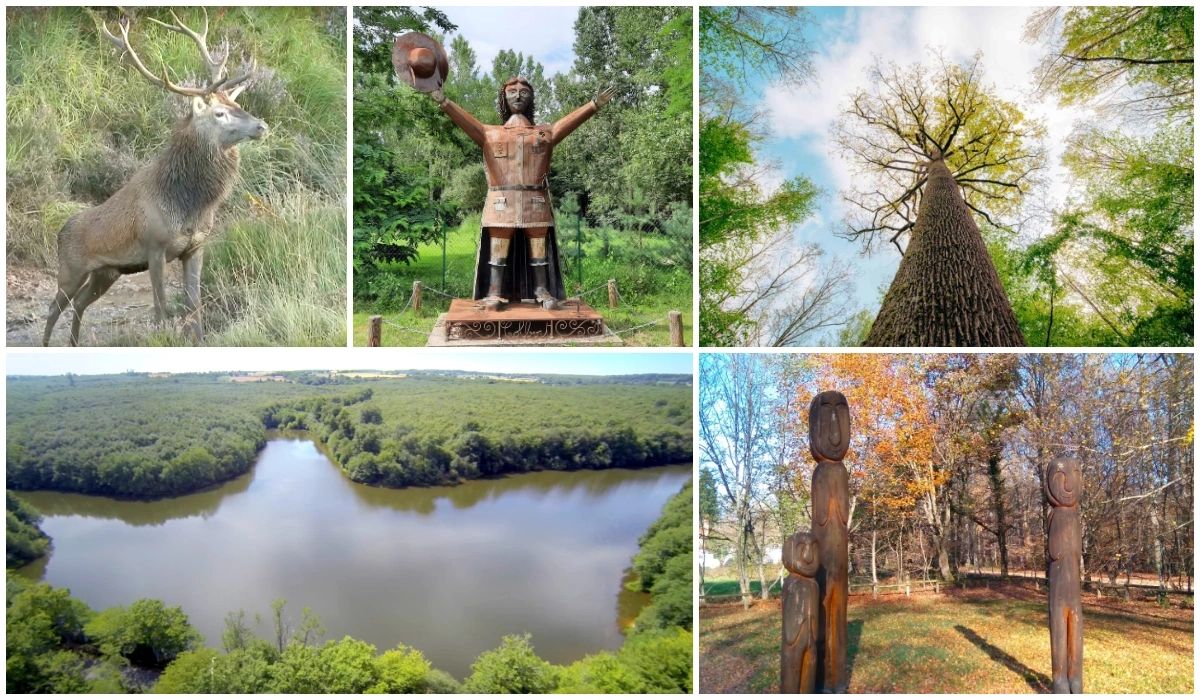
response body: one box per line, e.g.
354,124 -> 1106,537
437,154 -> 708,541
5,7 -> 346,345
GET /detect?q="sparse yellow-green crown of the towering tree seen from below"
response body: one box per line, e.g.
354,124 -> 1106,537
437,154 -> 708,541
833,54 -> 1045,253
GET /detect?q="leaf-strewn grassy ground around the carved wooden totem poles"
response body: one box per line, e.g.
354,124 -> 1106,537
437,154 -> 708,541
700,584 -> 1194,694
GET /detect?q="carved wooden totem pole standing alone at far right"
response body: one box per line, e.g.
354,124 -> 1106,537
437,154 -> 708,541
1046,459 -> 1084,693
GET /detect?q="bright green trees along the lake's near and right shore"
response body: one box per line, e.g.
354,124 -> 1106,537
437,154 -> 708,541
5,484 -> 692,694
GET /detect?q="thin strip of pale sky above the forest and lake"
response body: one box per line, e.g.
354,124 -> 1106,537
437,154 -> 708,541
5,348 -> 691,375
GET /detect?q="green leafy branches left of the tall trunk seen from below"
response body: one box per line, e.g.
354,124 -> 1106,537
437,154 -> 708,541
700,7 -> 850,346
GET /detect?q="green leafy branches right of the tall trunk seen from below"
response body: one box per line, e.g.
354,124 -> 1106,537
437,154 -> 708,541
1009,7 -> 1195,346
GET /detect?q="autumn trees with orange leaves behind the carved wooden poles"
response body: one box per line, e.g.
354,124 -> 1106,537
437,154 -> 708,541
698,354 -> 1194,600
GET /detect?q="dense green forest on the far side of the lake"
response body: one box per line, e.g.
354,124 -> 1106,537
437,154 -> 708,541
6,372 -> 691,498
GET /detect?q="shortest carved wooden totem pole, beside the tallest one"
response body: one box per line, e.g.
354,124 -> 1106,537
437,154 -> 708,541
779,532 -> 821,693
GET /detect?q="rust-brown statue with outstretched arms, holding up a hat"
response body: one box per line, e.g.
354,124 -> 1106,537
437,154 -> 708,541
392,31 -> 614,311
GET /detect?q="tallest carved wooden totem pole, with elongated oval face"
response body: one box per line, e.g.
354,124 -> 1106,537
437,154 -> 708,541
809,391 -> 850,693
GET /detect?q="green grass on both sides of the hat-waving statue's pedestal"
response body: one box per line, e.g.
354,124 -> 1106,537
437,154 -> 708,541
354,217 -> 692,346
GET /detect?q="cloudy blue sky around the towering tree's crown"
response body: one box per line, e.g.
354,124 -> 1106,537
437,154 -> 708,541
748,7 -> 1090,340
